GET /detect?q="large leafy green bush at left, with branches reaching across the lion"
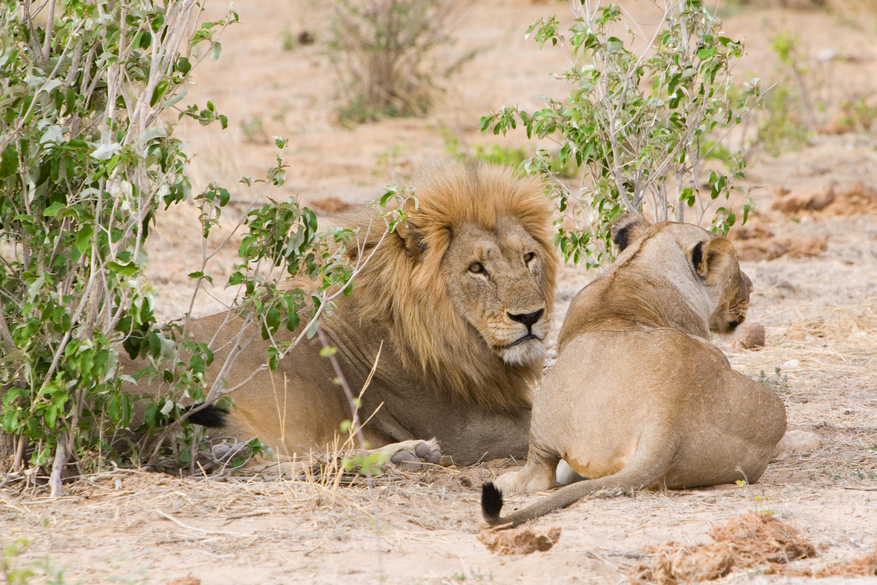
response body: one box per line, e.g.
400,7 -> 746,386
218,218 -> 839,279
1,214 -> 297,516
0,0 -> 366,484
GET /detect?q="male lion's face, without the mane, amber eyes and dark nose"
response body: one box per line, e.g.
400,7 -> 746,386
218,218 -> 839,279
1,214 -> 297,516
441,218 -> 552,365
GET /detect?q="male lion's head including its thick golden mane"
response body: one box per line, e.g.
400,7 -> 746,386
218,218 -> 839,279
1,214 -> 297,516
354,157 -> 557,408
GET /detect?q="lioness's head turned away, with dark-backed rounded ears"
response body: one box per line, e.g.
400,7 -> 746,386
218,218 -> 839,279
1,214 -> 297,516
612,214 -> 752,333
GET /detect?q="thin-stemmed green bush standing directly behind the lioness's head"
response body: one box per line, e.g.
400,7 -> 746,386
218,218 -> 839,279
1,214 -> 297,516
481,0 -> 761,266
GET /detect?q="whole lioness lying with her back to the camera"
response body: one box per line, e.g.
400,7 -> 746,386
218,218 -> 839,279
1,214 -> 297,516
481,215 -> 786,525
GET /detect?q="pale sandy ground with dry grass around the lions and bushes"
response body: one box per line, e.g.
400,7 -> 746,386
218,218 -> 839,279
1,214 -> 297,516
0,0 -> 877,585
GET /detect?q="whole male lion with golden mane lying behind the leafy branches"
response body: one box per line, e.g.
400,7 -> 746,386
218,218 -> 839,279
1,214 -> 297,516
141,163 -> 557,465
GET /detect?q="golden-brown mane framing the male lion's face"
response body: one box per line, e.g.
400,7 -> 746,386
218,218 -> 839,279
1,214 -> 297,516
342,163 -> 557,411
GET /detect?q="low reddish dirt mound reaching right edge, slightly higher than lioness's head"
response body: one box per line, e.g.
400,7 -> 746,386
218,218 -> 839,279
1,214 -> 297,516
771,182 -> 877,217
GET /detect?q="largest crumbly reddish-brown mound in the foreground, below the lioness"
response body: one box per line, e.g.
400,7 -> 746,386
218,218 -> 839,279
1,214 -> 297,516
633,512 -> 816,585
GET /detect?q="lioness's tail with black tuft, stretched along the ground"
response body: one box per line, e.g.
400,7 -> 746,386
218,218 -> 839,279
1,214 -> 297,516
481,440 -> 675,527
